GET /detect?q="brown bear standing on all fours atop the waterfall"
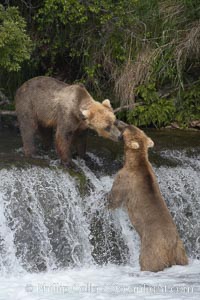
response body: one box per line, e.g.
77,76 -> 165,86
15,76 -> 121,163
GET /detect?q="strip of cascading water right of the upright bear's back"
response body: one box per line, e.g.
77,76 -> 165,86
157,151 -> 200,259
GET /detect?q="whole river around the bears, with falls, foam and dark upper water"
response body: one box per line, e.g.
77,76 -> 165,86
0,131 -> 200,300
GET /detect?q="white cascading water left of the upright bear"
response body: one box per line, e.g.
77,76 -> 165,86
0,163 -> 131,271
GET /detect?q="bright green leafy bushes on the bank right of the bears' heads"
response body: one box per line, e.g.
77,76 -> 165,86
126,82 -> 200,128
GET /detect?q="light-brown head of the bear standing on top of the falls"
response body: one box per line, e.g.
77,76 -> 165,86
81,99 -> 122,142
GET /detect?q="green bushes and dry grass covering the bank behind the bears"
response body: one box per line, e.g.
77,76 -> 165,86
0,0 -> 200,127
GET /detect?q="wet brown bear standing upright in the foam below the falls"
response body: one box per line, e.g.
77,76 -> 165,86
108,123 -> 188,272
